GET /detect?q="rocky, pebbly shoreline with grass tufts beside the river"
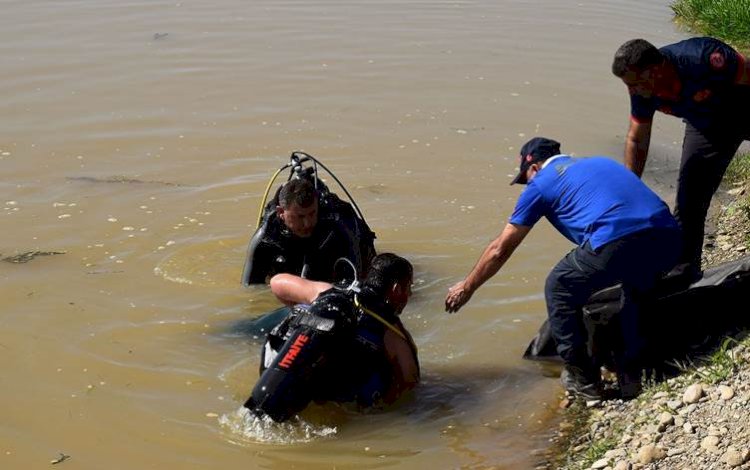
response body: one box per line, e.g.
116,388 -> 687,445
548,182 -> 750,470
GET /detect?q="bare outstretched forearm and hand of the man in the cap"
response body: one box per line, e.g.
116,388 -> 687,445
445,224 -> 531,313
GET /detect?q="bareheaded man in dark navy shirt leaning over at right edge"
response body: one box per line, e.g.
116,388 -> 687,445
612,37 -> 750,278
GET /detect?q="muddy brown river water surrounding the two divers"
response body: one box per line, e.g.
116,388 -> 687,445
0,0 -> 684,470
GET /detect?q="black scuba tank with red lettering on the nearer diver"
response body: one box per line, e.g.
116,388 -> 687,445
244,289 -> 355,422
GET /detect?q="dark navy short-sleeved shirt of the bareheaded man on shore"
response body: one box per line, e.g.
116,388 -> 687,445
630,37 -> 750,129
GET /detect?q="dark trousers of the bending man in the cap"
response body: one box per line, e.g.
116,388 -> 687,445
544,229 -> 680,371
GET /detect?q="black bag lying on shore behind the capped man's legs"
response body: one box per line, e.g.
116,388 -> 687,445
523,256 -> 750,370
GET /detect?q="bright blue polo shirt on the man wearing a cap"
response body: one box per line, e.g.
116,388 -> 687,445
510,155 -> 677,250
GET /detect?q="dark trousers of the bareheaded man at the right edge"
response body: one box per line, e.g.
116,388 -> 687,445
674,121 -> 750,269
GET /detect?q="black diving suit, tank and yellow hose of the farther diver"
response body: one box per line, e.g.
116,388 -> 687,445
242,152 -> 376,286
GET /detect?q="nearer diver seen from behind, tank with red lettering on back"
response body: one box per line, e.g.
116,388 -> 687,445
245,253 -> 420,422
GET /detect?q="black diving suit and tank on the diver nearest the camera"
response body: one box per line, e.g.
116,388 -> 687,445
250,288 -> 419,421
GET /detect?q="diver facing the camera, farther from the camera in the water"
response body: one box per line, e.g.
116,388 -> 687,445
243,168 -> 375,285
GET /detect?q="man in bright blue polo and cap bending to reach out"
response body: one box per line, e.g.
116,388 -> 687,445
445,137 -> 680,399
